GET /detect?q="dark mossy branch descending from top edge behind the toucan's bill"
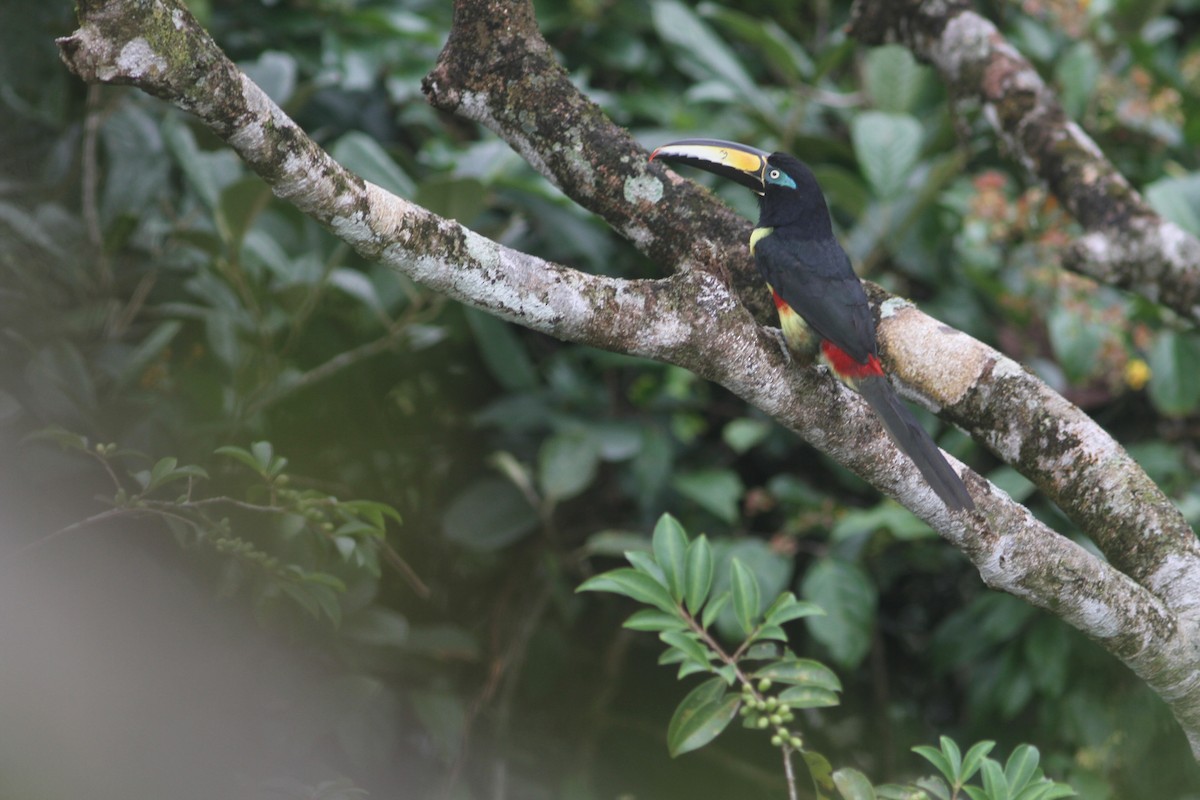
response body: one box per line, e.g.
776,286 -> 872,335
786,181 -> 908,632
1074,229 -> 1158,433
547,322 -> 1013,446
422,0 -> 774,320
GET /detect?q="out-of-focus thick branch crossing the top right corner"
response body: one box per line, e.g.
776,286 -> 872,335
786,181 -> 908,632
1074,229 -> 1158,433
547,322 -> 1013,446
850,0 -> 1200,321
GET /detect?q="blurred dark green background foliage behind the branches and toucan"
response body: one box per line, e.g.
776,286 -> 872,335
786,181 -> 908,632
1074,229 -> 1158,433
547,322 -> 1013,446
0,0 -> 1200,800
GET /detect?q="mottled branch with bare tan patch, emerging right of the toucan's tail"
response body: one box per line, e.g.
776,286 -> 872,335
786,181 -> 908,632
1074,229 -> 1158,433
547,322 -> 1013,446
869,285 -> 1200,636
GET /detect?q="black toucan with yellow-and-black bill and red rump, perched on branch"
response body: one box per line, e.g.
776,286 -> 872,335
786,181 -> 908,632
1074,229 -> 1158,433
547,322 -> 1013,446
650,139 -> 974,511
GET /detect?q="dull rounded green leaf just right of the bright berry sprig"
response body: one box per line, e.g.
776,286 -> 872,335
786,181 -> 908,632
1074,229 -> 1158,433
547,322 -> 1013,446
802,558 -> 876,669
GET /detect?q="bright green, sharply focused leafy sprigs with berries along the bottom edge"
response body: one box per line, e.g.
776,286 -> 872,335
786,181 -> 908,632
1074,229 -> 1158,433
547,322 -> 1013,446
578,515 -> 1075,800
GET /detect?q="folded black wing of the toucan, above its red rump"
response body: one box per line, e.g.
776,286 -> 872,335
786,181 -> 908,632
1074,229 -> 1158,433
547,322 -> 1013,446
754,231 -> 877,363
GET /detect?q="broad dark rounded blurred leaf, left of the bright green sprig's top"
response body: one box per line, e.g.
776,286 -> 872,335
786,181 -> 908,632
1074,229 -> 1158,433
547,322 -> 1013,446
442,477 -> 538,553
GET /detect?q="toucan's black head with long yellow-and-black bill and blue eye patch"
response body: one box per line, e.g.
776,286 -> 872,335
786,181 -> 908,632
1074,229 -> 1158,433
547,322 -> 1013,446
650,139 -> 832,235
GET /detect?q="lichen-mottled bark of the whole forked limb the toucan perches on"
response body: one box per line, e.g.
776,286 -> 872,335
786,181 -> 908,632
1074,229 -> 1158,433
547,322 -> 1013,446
59,0 -> 1200,753
